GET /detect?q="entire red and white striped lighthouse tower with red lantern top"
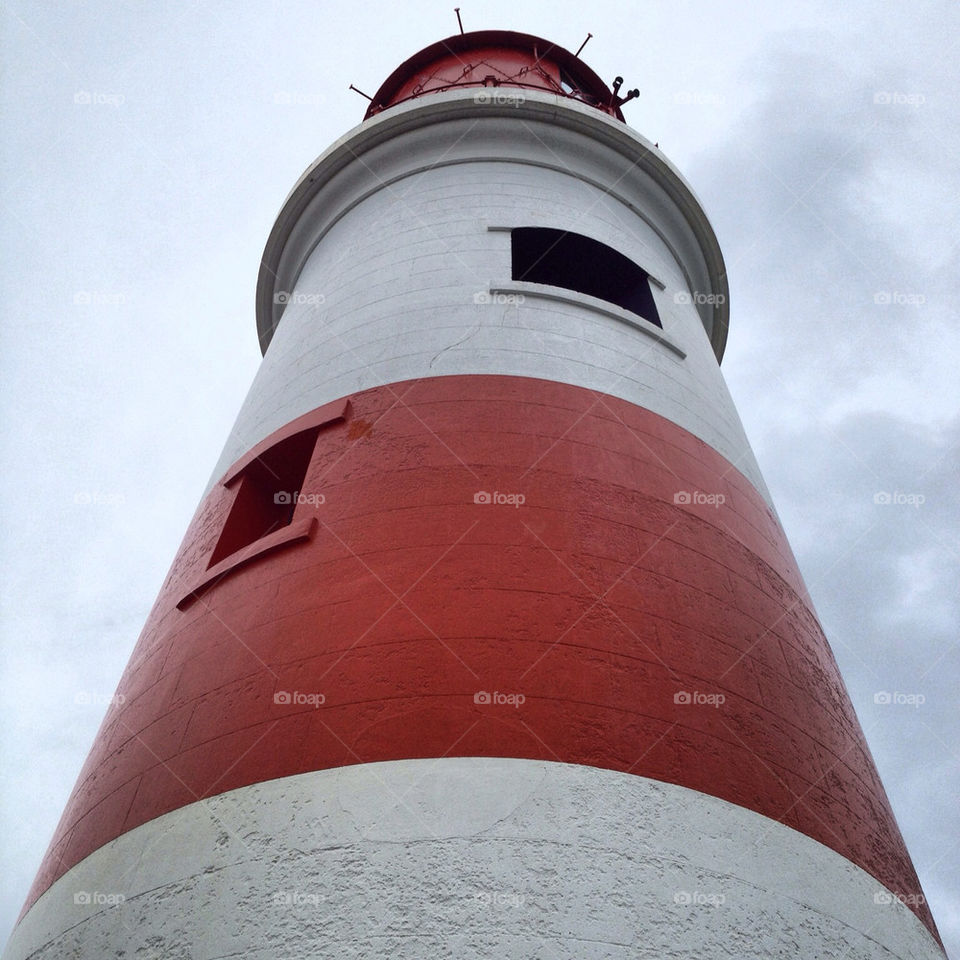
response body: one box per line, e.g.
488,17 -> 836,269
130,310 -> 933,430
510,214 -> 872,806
5,31 -> 943,960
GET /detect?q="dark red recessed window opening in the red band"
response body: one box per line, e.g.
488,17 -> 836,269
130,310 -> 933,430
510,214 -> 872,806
207,427 -> 320,569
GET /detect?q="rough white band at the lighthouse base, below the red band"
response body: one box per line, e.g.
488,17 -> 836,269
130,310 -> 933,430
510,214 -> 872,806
4,758 -> 943,960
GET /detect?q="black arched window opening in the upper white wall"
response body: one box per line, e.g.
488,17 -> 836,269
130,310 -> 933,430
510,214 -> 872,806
510,227 -> 662,327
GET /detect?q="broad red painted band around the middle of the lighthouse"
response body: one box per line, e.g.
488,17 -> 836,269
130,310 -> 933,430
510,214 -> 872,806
20,376 -> 936,935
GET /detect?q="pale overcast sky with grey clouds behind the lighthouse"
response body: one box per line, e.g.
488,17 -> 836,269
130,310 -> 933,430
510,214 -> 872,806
0,0 -> 960,960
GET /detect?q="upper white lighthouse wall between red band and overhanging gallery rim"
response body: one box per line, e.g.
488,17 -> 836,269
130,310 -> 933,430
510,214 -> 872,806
211,96 -> 768,496
